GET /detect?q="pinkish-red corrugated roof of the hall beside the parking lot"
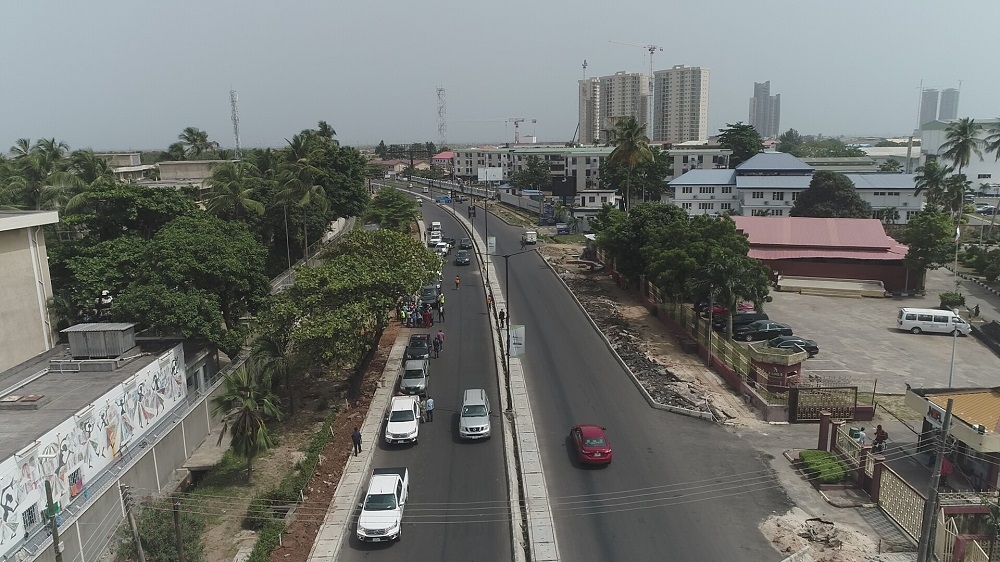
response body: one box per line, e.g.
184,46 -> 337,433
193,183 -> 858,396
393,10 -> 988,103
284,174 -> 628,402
732,216 -> 898,251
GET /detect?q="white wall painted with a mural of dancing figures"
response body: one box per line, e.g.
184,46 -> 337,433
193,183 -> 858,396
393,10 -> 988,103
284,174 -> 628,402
0,345 -> 187,556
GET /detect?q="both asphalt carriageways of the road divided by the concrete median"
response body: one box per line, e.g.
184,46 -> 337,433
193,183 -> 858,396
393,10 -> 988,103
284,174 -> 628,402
341,186 -> 790,562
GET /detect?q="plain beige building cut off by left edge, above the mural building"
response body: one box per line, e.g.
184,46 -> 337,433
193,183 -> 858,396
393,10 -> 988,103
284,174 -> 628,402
0,211 -> 58,372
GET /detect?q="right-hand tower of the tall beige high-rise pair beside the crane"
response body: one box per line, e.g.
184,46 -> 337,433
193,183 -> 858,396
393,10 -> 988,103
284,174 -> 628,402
650,64 -> 709,143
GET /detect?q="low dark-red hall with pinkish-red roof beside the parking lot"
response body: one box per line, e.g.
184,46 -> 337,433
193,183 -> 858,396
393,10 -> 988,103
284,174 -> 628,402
732,216 -> 923,292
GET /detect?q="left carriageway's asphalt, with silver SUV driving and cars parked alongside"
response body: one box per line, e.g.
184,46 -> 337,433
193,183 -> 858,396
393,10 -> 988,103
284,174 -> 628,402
339,202 -> 512,562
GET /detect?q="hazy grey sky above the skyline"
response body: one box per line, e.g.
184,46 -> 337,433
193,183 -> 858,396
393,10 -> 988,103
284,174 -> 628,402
0,0 -> 1000,151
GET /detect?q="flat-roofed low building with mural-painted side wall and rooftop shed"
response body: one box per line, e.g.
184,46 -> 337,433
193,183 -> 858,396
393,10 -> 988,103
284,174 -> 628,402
0,324 -> 224,561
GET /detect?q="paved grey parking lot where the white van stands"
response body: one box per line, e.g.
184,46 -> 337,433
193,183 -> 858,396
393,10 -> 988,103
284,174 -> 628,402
764,269 -> 1000,393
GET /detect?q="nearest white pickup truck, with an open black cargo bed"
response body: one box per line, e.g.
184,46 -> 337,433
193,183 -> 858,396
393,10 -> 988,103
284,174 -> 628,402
358,468 -> 410,542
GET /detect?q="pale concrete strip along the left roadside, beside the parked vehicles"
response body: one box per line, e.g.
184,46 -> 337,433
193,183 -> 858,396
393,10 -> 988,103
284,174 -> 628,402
307,338 -> 406,562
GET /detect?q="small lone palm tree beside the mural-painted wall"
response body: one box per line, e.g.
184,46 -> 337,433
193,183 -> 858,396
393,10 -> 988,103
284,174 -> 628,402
212,361 -> 281,482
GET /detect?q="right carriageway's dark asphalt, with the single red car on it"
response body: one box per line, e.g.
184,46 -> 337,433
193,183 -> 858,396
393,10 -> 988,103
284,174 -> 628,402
476,212 -> 791,562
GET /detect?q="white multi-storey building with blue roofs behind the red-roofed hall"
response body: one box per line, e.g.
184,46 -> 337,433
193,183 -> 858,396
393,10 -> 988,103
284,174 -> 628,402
670,152 -> 924,224
